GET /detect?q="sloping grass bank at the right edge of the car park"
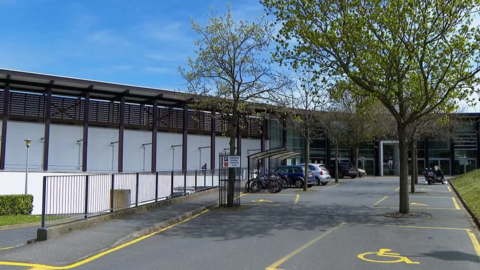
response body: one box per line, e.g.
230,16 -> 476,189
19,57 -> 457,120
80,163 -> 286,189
450,170 -> 480,219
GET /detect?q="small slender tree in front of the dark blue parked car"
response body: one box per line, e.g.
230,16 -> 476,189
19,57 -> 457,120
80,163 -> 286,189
273,75 -> 329,191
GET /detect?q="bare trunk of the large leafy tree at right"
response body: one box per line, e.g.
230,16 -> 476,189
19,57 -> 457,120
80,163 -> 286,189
398,124 -> 410,214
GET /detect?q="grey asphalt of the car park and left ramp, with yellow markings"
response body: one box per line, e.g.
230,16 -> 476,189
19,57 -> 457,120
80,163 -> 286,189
0,177 -> 480,270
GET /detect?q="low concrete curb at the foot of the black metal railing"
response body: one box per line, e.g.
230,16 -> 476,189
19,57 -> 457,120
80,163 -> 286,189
36,187 -> 218,241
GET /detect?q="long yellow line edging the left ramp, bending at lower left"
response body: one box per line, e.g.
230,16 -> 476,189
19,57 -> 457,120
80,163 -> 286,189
0,209 -> 209,270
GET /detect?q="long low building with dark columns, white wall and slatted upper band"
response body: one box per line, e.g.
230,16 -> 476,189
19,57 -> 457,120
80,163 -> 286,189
0,69 -> 480,176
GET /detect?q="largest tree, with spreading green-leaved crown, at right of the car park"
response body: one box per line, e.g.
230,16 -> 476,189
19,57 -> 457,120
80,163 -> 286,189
263,0 -> 480,213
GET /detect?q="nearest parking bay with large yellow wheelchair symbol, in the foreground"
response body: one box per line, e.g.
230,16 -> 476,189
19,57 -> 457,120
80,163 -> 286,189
266,223 -> 480,270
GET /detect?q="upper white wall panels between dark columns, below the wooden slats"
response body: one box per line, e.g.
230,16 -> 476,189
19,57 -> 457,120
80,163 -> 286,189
0,121 -> 262,172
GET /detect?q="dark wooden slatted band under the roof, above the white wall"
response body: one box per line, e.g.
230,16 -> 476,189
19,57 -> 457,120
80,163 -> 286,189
0,87 -> 269,139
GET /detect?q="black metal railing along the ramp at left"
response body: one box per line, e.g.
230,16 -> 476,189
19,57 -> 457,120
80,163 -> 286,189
42,169 -> 225,228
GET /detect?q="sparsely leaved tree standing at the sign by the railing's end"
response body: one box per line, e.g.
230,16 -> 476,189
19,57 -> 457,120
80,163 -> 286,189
179,5 -> 287,207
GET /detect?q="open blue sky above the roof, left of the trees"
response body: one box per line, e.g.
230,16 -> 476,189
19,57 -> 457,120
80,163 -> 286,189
0,0 -> 263,90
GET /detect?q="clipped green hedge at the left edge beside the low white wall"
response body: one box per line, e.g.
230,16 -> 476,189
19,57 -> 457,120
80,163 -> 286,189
0,195 -> 33,216
